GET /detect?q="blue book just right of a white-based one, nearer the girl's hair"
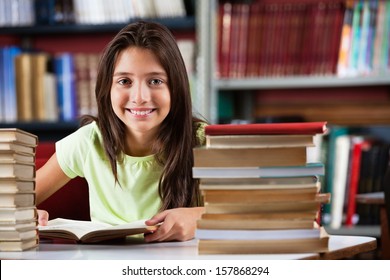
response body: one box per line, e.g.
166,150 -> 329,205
54,53 -> 77,121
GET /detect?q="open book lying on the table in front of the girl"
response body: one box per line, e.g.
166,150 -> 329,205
38,218 -> 158,243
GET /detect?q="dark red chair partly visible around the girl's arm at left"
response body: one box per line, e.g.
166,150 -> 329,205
35,142 -> 90,221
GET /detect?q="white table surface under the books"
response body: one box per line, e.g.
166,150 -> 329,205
0,235 -> 377,260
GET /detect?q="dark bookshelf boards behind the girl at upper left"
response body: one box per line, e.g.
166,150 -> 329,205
0,0 -> 195,141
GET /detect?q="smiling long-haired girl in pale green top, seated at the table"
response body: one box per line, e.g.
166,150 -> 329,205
36,22 -> 206,242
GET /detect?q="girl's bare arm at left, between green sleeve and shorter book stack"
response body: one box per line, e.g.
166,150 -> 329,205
35,153 -> 70,205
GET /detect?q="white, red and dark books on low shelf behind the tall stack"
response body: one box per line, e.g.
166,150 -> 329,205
323,126 -> 390,229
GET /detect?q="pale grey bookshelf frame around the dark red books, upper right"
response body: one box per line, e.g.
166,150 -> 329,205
196,0 -> 390,124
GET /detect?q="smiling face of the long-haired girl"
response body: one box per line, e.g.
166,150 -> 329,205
111,47 -> 171,138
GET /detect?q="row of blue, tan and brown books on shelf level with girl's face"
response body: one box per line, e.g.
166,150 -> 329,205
0,39 -> 194,122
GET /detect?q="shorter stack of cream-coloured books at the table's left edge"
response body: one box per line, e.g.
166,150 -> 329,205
0,128 -> 39,251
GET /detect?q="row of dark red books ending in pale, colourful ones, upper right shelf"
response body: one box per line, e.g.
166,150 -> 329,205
217,0 -> 390,78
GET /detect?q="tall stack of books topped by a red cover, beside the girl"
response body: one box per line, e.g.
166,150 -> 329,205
193,122 -> 330,254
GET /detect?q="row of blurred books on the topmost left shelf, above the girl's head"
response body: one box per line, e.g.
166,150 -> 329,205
0,0 -> 192,27
